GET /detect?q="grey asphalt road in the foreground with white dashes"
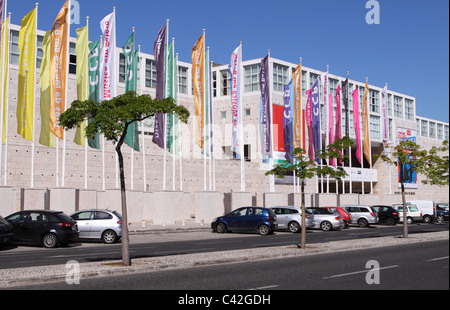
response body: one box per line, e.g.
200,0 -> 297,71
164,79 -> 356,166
6,240 -> 449,290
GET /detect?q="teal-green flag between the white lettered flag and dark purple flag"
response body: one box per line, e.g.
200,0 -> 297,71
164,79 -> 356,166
122,32 -> 141,152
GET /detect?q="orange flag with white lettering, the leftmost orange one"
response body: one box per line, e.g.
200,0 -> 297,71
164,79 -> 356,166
50,0 -> 70,140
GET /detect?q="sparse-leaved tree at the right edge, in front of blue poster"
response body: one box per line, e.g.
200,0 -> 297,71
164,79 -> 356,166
380,139 -> 449,238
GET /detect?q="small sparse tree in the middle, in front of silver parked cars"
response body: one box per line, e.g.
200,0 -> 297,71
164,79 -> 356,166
266,136 -> 353,249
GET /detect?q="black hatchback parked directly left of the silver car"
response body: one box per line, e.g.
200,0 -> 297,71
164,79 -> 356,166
5,210 -> 78,248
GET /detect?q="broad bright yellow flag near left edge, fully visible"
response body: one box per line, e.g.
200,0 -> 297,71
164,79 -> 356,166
17,9 -> 36,141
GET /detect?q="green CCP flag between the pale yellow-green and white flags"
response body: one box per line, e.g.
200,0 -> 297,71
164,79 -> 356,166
88,40 -> 101,150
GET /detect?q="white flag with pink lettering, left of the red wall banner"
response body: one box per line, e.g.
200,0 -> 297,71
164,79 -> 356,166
228,45 -> 243,159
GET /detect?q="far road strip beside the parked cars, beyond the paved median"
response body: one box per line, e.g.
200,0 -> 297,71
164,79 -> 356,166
0,223 -> 449,269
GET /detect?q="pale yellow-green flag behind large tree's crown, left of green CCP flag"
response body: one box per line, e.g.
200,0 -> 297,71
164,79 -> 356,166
73,26 -> 89,146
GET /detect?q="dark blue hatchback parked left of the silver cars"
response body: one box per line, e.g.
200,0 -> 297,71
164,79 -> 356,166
211,207 -> 278,235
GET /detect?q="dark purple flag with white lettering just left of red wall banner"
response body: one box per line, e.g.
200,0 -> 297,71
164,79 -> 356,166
259,55 -> 272,156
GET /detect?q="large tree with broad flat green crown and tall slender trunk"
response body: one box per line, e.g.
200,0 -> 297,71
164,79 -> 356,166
59,91 -> 190,266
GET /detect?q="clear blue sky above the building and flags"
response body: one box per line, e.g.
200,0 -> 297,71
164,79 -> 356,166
4,0 -> 449,122
